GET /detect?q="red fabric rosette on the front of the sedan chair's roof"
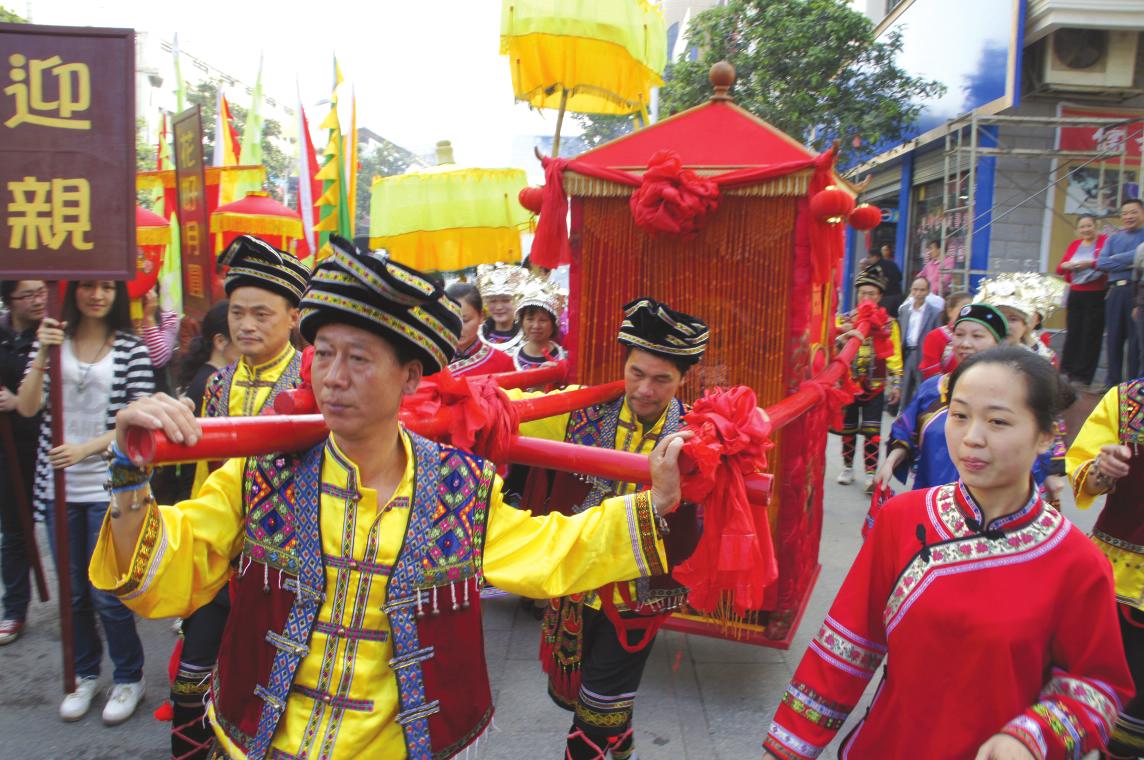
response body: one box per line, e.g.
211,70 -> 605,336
629,149 -> 718,236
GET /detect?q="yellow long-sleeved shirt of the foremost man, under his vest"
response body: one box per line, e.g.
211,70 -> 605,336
90,433 -> 666,758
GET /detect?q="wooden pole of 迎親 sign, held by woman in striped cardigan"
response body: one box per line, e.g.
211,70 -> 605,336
47,280 -> 75,694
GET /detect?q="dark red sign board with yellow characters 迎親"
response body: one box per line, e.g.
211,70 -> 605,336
0,24 -> 135,279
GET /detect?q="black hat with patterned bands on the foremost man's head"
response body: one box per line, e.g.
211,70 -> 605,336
300,235 -> 461,374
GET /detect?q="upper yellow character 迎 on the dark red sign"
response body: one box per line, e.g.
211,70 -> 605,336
3,53 -> 92,129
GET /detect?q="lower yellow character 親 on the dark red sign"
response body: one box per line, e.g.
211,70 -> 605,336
6,176 -> 93,251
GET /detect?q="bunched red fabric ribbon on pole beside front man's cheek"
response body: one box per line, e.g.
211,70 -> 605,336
402,372 -> 519,461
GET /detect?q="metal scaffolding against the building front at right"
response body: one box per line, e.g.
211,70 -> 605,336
940,113 -> 1144,290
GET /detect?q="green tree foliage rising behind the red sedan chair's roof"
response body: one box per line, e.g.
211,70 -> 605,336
660,0 -> 945,156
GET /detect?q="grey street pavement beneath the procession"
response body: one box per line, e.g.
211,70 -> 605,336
0,436 -> 1097,760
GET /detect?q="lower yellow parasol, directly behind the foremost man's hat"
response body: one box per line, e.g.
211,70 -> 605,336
370,141 -> 530,271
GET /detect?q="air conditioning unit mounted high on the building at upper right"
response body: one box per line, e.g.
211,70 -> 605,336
1044,29 -> 1139,90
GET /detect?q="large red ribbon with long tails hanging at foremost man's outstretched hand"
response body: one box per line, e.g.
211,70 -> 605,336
672,387 -> 778,615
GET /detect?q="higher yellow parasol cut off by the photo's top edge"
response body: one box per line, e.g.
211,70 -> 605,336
501,0 -> 667,156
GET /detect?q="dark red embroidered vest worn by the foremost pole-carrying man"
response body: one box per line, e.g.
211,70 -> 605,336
210,433 -> 495,760
